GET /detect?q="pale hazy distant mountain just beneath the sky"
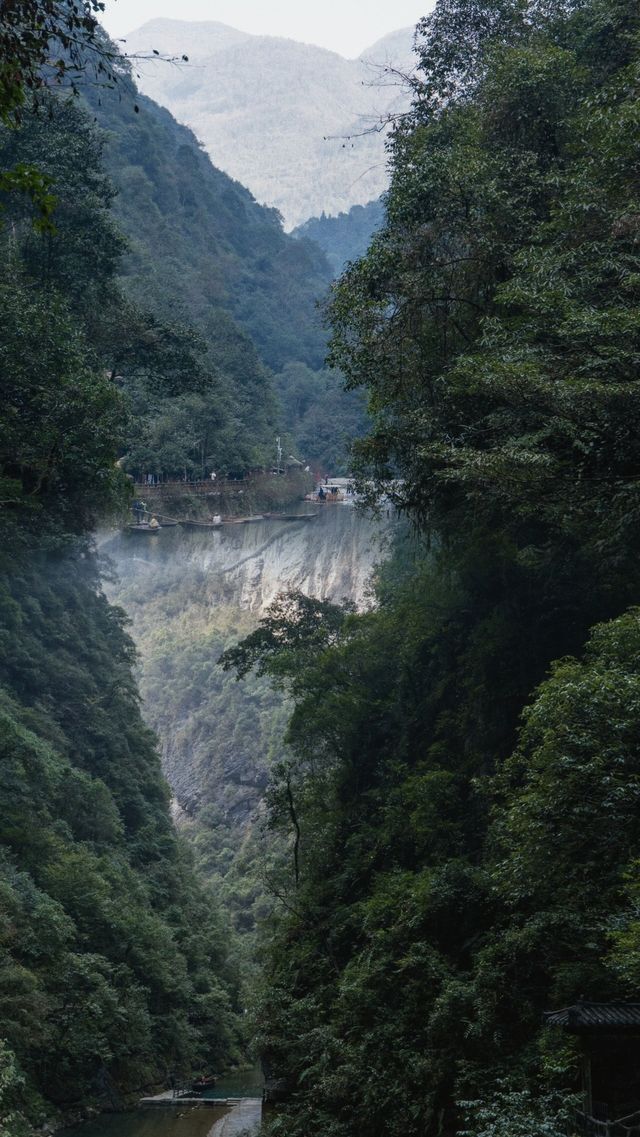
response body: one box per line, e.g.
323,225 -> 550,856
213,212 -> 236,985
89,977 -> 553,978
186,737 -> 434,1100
125,19 -> 413,229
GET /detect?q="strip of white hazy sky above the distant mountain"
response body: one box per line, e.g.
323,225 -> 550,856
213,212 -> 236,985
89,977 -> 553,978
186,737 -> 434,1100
102,0 -> 433,58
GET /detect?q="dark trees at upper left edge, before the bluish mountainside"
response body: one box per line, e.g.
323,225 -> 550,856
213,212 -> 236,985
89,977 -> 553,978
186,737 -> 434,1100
0,97 -> 218,523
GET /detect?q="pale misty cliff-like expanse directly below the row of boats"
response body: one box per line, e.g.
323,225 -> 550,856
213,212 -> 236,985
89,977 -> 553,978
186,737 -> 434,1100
101,505 -> 393,847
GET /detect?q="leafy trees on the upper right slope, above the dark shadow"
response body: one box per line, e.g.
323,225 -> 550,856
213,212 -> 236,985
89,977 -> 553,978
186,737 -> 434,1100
333,6 -> 639,575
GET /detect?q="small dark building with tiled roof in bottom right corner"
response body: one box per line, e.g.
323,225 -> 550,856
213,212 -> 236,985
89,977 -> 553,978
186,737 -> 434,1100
545,999 -> 640,1123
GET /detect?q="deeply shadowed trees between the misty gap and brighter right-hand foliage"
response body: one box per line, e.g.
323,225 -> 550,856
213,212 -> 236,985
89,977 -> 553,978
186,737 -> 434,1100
229,561 -> 493,1135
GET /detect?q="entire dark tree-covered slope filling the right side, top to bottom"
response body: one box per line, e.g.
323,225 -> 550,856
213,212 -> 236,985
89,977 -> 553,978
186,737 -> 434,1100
219,0 -> 640,1137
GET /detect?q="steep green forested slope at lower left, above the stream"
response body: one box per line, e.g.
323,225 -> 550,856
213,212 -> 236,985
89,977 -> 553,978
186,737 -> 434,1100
0,555 -> 243,1119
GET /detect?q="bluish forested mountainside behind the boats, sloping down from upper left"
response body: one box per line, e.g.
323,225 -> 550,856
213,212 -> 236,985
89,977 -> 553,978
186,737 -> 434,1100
81,50 -> 366,474
